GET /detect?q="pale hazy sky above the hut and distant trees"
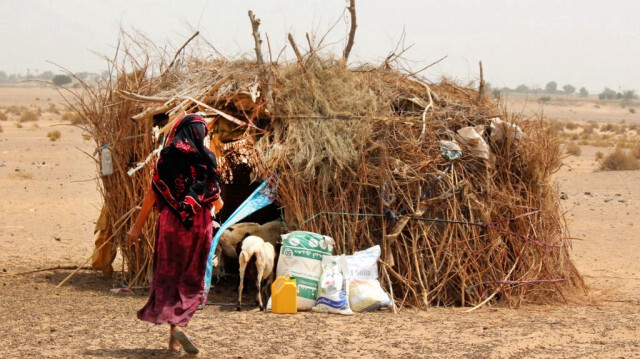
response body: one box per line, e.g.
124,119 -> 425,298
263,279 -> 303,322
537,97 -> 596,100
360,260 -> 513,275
0,0 -> 640,92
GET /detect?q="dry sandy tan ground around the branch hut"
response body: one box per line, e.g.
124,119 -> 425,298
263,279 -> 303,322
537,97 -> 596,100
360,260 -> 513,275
0,89 -> 640,358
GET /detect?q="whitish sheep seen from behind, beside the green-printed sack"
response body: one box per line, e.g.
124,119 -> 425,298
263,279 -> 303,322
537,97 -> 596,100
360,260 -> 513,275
237,234 -> 279,311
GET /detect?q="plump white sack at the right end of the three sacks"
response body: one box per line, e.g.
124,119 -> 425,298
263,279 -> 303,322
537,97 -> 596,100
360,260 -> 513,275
346,246 -> 393,312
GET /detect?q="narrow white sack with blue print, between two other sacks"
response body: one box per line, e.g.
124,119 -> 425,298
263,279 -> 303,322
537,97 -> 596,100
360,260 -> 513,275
312,256 -> 353,314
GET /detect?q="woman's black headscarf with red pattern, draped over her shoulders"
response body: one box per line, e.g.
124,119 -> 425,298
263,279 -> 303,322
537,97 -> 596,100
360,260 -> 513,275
152,115 -> 220,228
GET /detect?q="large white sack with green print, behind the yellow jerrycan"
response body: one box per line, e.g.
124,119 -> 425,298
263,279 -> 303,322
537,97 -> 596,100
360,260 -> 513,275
276,231 -> 334,310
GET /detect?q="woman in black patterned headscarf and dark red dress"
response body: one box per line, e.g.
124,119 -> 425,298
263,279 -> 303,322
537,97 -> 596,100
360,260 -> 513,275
127,115 -> 222,354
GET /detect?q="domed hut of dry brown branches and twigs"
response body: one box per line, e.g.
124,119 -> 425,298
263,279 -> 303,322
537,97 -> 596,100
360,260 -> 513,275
73,30 -> 584,308
